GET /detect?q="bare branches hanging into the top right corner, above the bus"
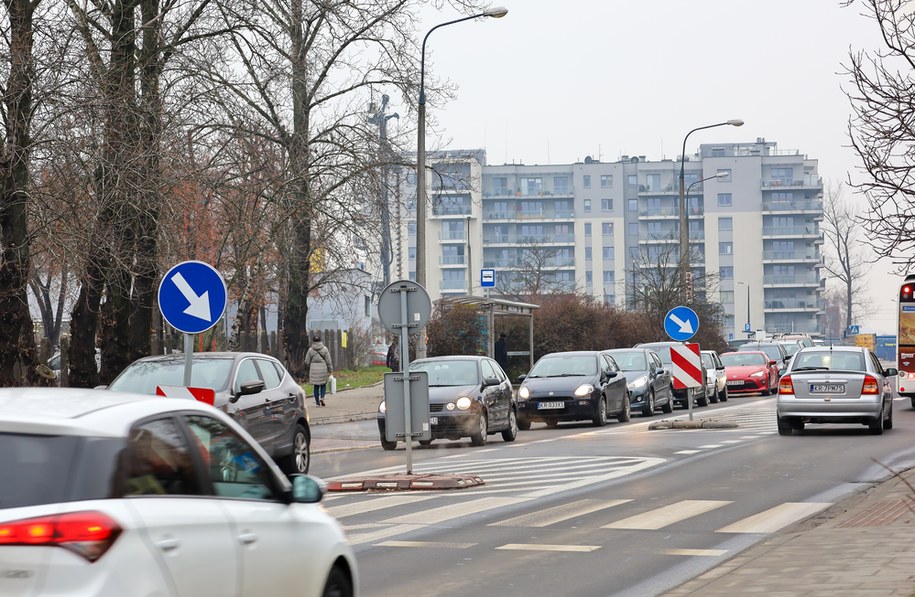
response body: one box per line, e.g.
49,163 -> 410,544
845,0 -> 915,271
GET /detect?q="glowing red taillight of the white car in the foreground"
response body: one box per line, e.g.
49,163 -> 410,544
0,511 -> 121,562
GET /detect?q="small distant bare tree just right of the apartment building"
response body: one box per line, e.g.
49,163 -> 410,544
821,183 -> 869,329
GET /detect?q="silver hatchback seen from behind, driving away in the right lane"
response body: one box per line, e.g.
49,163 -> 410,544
775,346 -> 898,435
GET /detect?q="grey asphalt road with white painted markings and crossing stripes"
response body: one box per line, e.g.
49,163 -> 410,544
313,397 -> 915,597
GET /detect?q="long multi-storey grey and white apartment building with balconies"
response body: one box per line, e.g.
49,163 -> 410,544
394,139 -> 825,338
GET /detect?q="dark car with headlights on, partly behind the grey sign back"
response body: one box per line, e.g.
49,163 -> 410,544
378,356 -> 519,450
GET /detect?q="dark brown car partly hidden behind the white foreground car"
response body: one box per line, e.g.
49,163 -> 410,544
108,352 -> 311,474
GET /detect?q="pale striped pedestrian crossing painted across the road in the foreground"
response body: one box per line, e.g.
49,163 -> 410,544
326,494 -> 832,556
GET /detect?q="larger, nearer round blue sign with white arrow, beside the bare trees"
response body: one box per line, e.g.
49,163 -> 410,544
159,261 -> 226,334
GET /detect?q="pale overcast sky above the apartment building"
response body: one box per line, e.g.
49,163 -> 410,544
392,0 -> 901,333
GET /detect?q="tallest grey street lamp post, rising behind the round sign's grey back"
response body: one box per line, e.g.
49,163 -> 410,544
416,6 -> 508,359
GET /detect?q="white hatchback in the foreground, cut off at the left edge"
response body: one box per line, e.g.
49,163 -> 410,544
0,388 -> 358,597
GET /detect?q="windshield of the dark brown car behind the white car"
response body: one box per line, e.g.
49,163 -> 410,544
108,358 -> 233,394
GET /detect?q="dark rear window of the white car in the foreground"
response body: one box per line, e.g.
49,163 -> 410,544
0,433 -> 124,509
